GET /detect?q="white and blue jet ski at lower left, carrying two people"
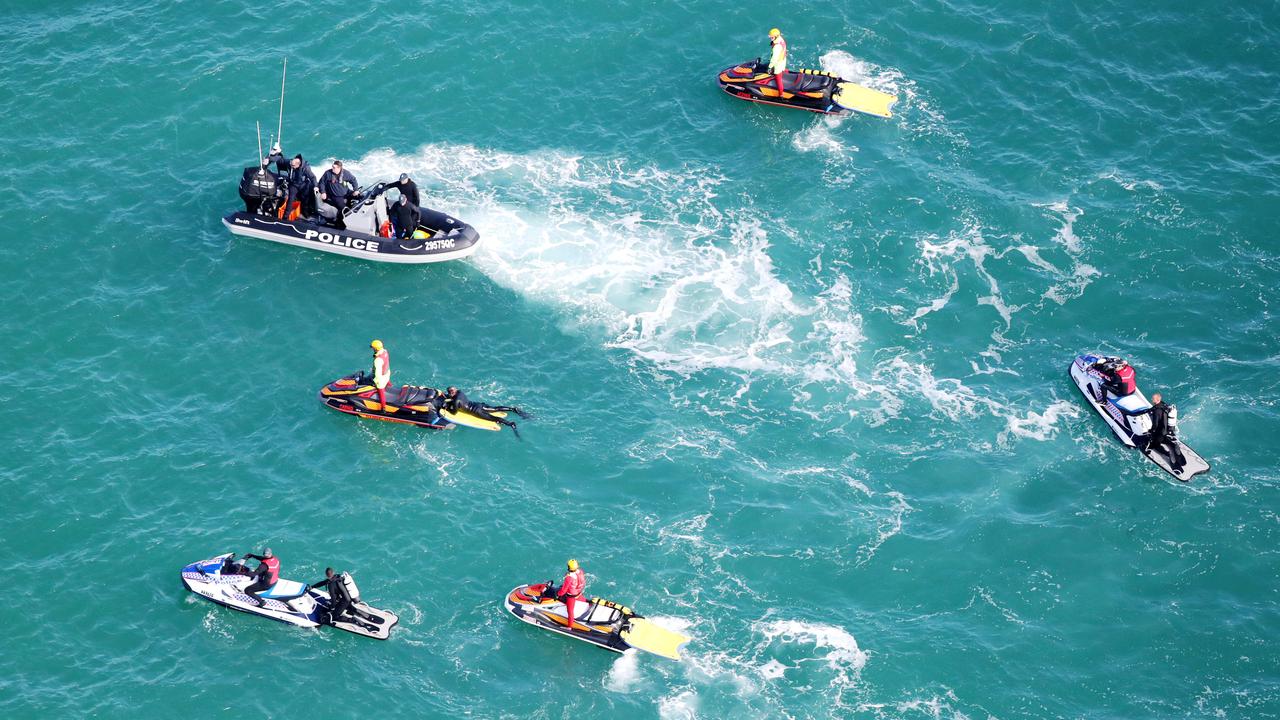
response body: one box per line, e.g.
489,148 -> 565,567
182,552 -> 399,641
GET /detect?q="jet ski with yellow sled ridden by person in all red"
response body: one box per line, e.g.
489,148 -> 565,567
503,582 -> 690,660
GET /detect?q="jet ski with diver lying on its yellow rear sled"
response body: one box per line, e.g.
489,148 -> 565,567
320,370 -> 507,432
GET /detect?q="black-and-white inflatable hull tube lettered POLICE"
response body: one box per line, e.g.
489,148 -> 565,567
223,208 -> 480,264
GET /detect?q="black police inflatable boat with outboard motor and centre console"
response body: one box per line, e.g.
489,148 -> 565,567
223,168 -> 480,263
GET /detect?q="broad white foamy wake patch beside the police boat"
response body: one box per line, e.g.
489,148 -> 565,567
352,145 -> 863,382
